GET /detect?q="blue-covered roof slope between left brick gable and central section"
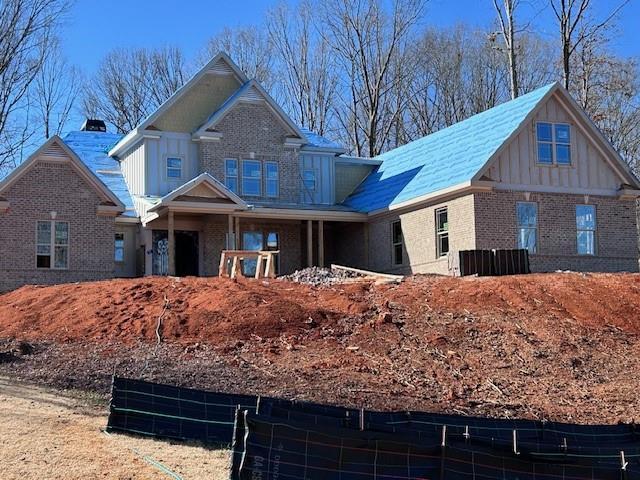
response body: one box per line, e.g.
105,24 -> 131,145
63,131 -> 136,216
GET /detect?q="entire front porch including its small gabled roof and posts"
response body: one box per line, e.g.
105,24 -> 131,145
141,173 -> 367,276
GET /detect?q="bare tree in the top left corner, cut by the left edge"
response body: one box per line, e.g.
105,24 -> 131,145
0,0 -> 68,169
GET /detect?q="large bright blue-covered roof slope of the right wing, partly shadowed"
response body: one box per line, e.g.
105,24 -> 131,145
343,83 -> 556,212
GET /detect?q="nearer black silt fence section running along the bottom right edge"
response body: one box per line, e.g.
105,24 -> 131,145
231,412 -> 640,480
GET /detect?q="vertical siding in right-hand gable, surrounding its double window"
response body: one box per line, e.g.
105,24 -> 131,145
485,96 -> 620,194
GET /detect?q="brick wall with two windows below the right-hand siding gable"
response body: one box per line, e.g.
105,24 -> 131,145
474,191 -> 638,271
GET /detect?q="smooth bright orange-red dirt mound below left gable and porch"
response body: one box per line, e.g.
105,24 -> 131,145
0,277 -> 368,343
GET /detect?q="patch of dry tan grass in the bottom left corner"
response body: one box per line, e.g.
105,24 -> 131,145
0,377 -> 229,480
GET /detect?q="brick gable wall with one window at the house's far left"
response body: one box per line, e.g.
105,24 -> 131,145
0,162 -> 115,291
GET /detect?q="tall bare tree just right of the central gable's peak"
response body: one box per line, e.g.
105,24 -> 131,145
267,1 -> 337,135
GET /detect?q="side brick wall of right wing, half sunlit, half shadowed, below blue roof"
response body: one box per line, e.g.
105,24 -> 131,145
368,195 -> 475,274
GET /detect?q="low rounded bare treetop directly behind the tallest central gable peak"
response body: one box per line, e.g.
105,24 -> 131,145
200,26 -> 273,90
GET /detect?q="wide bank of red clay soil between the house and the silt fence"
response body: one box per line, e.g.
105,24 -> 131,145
0,273 -> 640,423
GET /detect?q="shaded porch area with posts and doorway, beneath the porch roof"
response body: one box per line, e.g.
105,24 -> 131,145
142,210 -> 366,276
